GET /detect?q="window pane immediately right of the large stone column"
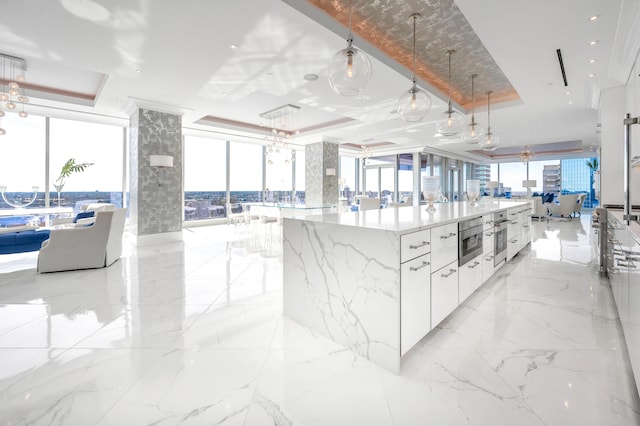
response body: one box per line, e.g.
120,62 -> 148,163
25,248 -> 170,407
183,135 -> 227,221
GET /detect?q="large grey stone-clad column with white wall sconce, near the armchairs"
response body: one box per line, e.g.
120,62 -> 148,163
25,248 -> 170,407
129,108 -> 183,245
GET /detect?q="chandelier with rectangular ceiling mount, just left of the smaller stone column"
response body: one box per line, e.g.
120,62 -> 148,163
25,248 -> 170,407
260,104 -> 300,165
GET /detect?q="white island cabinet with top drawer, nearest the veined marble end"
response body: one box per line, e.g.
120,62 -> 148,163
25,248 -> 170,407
400,229 -> 431,356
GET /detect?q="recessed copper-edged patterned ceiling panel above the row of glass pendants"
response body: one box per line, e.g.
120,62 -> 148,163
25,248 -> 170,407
307,0 -> 520,110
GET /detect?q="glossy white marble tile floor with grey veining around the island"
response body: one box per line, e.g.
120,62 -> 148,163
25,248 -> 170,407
0,214 -> 640,425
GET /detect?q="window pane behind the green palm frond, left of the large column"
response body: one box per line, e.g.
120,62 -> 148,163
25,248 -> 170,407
49,118 -> 126,207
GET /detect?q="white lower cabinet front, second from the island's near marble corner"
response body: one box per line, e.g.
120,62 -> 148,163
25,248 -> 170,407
431,260 -> 458,328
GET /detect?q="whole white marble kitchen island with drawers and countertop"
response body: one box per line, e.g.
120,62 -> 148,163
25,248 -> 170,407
283,199 -> 532,373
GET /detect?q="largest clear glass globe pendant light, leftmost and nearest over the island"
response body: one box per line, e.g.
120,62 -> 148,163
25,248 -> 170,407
329,1 -> 371,96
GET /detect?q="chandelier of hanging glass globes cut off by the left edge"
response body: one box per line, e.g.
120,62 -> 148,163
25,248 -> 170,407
0,53 -> 29,135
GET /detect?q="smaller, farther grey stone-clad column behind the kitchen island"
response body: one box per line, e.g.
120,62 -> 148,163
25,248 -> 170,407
304,142 -> 340,207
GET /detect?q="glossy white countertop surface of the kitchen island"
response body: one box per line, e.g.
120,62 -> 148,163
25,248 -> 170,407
290,199 -> 530,233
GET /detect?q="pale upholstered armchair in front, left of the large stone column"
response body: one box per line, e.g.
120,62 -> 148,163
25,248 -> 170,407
37,211 -> 114,273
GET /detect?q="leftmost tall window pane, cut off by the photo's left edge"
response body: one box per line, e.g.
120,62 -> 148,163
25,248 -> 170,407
0,114 -> 46,209
